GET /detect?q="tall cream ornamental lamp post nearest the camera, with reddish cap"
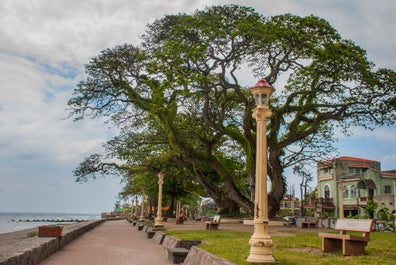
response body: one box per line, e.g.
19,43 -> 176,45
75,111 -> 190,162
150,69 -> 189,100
247,79 -> 275,264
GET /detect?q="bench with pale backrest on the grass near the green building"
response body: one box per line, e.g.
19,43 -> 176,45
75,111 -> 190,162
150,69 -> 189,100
319,219 -> 373,256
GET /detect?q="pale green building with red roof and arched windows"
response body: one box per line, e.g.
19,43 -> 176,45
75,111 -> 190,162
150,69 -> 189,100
314,156 -> 396,217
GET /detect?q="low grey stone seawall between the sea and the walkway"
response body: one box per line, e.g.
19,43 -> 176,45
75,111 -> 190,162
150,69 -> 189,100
0,219 -> 106,265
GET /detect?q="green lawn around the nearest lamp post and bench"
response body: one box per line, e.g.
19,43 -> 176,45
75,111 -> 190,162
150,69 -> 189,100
166,230 -> 396,265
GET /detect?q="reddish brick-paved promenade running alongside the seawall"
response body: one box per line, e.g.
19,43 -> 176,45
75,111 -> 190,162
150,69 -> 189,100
40,220 -> 173,265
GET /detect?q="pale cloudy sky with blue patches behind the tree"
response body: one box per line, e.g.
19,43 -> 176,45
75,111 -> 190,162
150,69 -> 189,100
0,0 -> 396,214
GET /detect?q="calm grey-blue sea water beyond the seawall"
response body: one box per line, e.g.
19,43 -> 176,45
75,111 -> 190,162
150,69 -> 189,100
0,212 -> 100,234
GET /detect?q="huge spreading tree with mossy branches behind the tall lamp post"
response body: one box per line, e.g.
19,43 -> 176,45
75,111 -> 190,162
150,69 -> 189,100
68,5 -> 396,216
